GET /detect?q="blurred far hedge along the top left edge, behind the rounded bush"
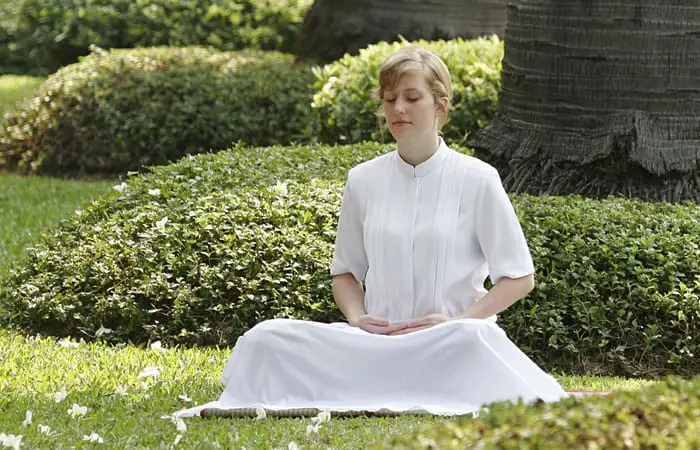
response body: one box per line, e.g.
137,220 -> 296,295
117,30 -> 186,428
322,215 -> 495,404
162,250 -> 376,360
0,0 -> 312,75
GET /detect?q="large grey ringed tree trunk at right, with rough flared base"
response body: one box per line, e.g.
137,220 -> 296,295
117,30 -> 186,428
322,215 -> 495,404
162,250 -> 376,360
471,0 -> 700,202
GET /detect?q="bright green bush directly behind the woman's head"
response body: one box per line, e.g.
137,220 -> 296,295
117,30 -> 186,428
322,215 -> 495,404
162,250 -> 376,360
313,36 -> 503,143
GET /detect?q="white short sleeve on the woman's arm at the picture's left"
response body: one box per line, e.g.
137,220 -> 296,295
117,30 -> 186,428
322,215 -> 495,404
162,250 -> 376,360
331,176 -> 368,281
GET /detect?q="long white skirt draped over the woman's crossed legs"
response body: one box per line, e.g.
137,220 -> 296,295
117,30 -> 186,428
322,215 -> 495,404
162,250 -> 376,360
176,319 -> 567,417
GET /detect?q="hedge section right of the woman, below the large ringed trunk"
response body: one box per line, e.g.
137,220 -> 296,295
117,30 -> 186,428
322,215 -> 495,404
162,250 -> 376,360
508,195 -> 700,377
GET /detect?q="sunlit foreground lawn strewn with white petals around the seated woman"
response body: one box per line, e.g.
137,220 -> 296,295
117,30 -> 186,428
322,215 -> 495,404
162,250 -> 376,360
0,331 -> 651,450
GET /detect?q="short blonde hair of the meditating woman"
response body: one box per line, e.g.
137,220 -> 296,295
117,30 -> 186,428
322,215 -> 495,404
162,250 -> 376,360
373,45 -> 452,130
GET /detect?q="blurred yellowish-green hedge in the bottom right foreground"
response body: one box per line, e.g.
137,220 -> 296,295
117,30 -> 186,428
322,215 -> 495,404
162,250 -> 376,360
384,377 -> 700,450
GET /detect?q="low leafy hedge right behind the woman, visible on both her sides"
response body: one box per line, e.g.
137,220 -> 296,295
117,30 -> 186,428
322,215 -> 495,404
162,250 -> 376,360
0,144 -> 700,376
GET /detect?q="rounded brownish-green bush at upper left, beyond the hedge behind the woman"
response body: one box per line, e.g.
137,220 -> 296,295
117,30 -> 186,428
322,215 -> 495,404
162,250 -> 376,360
0,47 -> 313,176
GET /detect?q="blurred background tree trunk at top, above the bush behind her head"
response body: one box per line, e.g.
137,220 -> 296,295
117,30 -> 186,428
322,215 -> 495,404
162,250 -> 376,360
297,0 -> 506,63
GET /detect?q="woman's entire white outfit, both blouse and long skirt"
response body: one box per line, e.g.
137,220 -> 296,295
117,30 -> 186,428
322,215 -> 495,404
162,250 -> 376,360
178,140 -> 567,416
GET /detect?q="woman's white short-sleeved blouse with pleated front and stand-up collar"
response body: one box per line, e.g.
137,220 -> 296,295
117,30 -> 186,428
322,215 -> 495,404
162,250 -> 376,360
331,139 -> 534,321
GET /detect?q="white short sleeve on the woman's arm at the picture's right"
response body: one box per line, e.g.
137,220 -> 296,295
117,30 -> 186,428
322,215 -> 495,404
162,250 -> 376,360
475,169 -> 535,285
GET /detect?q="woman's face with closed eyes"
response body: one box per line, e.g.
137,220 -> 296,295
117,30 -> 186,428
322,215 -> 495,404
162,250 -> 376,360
384,72 -> 441,141
